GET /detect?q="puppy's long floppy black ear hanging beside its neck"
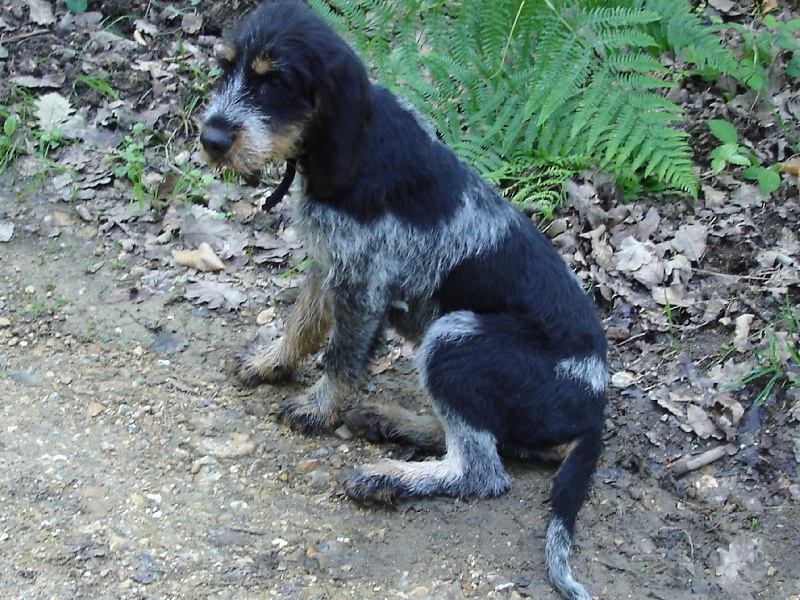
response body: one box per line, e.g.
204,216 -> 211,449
305,48 -> 373,198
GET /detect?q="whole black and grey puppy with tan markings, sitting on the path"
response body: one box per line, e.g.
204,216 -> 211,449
200,0 -> 607,599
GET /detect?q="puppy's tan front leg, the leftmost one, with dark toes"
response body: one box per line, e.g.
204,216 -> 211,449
237,265 -> 331,385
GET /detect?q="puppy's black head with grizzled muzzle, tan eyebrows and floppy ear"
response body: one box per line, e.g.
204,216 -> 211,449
200,0 -> 372,198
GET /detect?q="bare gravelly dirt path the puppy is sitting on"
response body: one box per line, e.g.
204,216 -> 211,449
0,183 -> 800,599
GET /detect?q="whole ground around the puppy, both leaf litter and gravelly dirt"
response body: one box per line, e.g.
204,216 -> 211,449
0,0 -> 800,600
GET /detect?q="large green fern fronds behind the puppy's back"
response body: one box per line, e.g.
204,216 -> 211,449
309,0 -> 746,202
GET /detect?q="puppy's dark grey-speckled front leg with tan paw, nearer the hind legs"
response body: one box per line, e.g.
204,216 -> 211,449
281,289 -> 386,434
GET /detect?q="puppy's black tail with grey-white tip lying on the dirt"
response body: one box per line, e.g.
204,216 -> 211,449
545,429 -> 602,600
